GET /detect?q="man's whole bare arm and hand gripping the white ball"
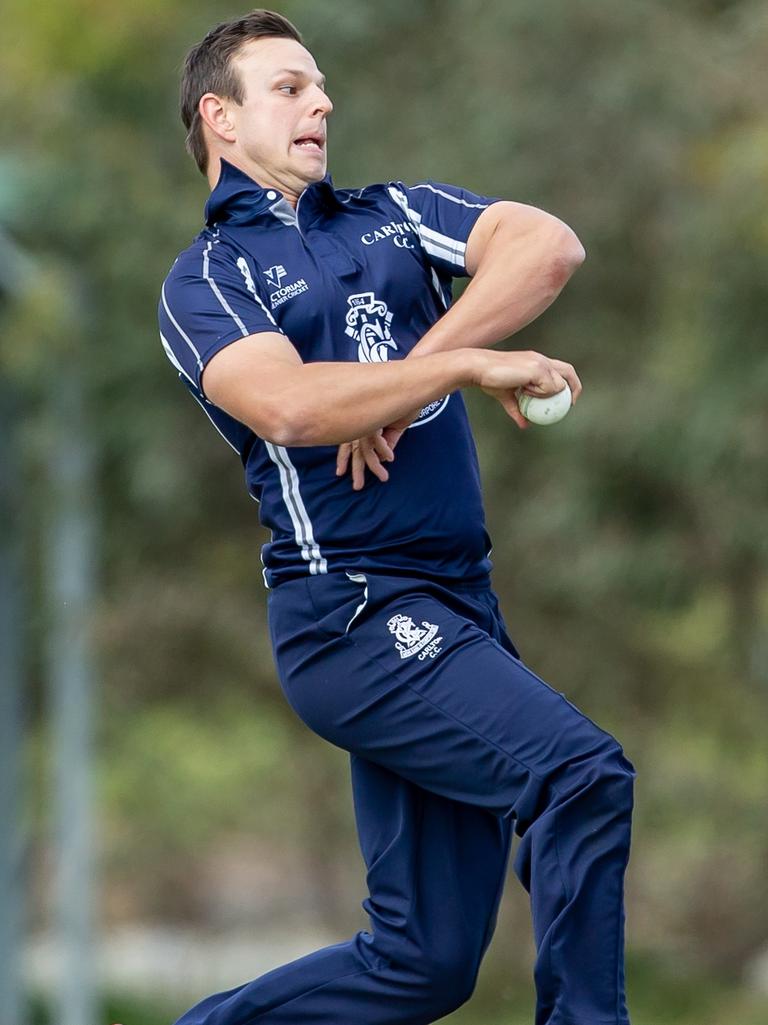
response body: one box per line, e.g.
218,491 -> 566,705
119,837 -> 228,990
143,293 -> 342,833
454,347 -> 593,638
202,332 -> 578,446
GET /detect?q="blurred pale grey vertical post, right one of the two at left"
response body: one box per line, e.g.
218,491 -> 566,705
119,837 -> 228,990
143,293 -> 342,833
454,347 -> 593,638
47,358 -> 97,1025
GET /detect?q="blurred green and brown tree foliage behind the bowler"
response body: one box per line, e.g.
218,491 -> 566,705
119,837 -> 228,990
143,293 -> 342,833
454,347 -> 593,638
0,0 -> 768,1025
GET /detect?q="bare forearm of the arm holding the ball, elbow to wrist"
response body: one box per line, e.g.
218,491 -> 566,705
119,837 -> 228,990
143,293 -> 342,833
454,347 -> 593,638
264,350 -> 475,446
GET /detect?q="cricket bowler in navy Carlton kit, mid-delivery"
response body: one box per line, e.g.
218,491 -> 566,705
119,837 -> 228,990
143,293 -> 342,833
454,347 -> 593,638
159,10 -> 635,1025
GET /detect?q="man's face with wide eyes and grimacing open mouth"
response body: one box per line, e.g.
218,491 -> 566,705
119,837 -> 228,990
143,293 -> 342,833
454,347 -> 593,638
228,37 -> 333,197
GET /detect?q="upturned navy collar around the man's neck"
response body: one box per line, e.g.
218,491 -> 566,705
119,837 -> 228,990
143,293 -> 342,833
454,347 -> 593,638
205,159 -> 342,226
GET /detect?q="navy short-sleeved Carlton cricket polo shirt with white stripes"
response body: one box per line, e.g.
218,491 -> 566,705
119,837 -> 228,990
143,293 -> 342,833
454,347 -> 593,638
159,161 -> 496,586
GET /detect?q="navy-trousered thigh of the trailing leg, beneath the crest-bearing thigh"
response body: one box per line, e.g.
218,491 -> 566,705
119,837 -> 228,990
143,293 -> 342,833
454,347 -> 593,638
351,755 -> 512,969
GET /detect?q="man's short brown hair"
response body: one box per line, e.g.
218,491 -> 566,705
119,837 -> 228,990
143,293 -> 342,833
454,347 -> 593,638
179,8 -> 304,174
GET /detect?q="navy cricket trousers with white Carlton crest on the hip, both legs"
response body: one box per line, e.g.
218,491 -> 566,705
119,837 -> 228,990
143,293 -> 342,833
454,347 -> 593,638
177,573 -> 636,1025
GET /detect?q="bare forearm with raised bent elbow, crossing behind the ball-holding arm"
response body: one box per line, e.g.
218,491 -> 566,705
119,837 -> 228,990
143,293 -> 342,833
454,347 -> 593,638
410,217 -> 583,357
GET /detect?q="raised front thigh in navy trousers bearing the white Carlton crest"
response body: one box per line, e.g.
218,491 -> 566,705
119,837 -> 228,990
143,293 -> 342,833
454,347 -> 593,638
271,576 -> 618,819
